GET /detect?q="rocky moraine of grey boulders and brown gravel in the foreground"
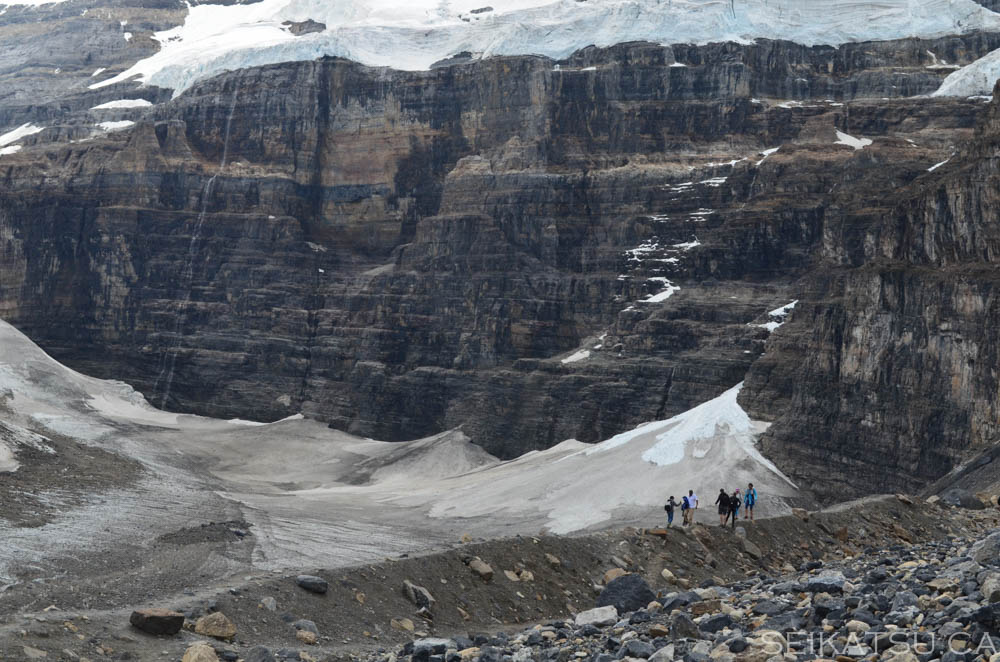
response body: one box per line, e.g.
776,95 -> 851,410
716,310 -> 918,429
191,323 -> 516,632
0,495 -> 1000,662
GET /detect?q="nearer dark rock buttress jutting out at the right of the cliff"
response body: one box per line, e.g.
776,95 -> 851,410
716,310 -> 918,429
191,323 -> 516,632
744,76 -> 1000,504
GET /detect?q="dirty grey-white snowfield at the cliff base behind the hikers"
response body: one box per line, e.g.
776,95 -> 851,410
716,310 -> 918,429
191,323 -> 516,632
0,322 -> 798,584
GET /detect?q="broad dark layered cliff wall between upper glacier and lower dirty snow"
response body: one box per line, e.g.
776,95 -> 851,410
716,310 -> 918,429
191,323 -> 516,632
0,26 -> 1000,491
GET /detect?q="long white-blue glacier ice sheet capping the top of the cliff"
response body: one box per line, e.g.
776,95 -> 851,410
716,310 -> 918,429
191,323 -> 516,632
82,0 -> 1000,94
